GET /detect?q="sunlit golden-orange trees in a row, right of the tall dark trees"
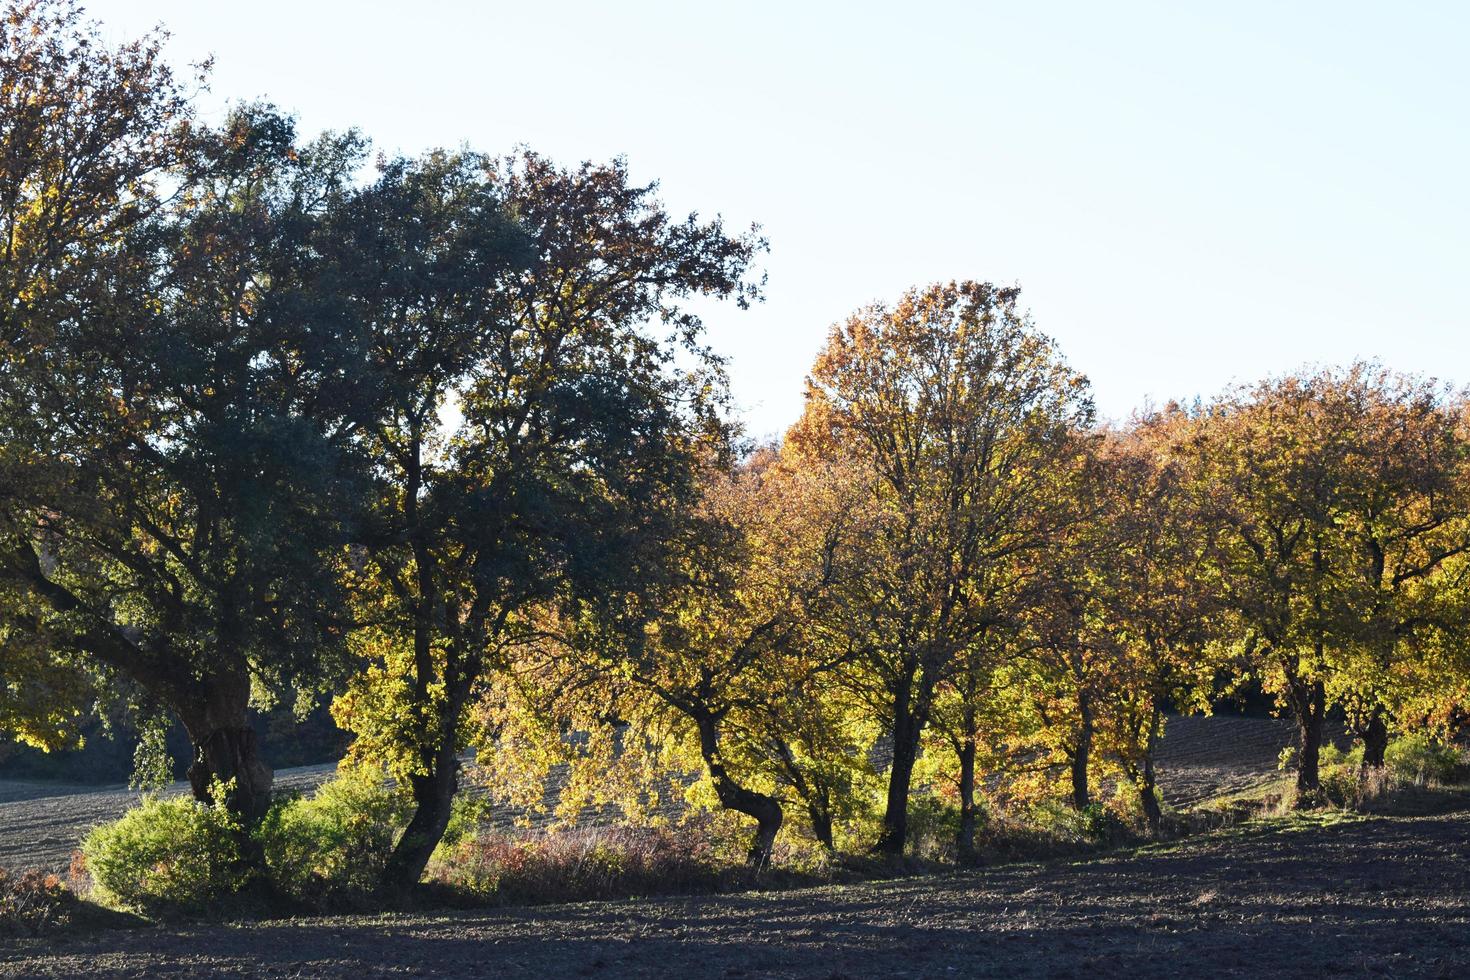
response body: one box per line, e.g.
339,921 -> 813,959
487,282 -> 1470,861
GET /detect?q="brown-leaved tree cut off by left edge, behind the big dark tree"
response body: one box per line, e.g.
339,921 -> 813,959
0,0 -> 188,748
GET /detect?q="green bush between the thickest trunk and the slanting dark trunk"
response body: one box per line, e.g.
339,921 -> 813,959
257,771 -> 409,907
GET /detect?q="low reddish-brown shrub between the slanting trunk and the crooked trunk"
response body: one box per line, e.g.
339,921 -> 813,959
429,827 -> 738,905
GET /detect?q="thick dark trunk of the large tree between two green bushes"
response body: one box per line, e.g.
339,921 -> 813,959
173,670 -> 275,827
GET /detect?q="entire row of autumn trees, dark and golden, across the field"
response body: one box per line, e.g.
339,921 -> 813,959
0,0 -> 1470,886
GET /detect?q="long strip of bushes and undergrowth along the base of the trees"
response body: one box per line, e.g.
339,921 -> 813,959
45,736 -> 1470,934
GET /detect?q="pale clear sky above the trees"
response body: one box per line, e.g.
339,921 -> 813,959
88,0 -> 1470,435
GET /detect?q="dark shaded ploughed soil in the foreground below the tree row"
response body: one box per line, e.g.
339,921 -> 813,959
0,798 -> 1470,980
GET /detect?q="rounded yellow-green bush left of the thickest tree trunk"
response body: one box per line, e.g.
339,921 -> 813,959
82,796 -> 251,915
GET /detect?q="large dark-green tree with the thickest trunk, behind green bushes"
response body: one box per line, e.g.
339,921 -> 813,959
3,101 -> 359,821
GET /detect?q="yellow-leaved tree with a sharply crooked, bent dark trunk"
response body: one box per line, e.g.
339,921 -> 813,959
482,450 -> 858,870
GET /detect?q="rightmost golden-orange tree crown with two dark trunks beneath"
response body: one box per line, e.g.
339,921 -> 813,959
1186,364 -> 1470,804
